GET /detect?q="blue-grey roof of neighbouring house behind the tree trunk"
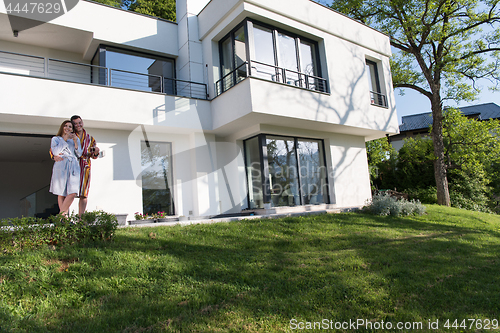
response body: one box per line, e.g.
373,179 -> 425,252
399,103 -> 500,132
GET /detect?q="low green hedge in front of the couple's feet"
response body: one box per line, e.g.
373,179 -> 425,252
0,211 -> 118,249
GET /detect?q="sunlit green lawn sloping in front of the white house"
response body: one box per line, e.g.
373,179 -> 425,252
0,206 -> 500,332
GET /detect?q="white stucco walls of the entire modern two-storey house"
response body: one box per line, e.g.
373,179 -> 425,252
0,0 -> 398,219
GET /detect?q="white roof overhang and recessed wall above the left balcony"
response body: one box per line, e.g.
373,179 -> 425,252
0,1 -> 179,56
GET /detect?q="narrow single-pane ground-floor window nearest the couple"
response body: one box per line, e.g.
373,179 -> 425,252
141,141 -> 175,215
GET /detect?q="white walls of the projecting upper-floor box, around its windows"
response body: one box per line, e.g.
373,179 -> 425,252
198,0 -> 398,138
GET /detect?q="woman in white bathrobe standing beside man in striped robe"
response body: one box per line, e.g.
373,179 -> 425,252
50,120 -> 82,215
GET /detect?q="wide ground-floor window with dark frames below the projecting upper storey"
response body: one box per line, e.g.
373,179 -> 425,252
245,134 -> 328,209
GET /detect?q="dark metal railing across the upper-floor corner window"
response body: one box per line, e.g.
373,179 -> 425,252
215,60 -> 328,96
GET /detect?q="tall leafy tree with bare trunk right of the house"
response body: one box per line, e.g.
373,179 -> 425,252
331,0 -> 500,206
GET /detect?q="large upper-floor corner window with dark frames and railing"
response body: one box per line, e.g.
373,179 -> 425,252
216,20 -> 328,94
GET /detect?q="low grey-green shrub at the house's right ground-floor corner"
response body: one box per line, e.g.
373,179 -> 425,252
363,194 -> 425,216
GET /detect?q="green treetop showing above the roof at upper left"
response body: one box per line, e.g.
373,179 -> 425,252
95,0 -> 176,22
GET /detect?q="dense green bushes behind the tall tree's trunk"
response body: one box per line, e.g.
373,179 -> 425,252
367,108 -> 500,211
